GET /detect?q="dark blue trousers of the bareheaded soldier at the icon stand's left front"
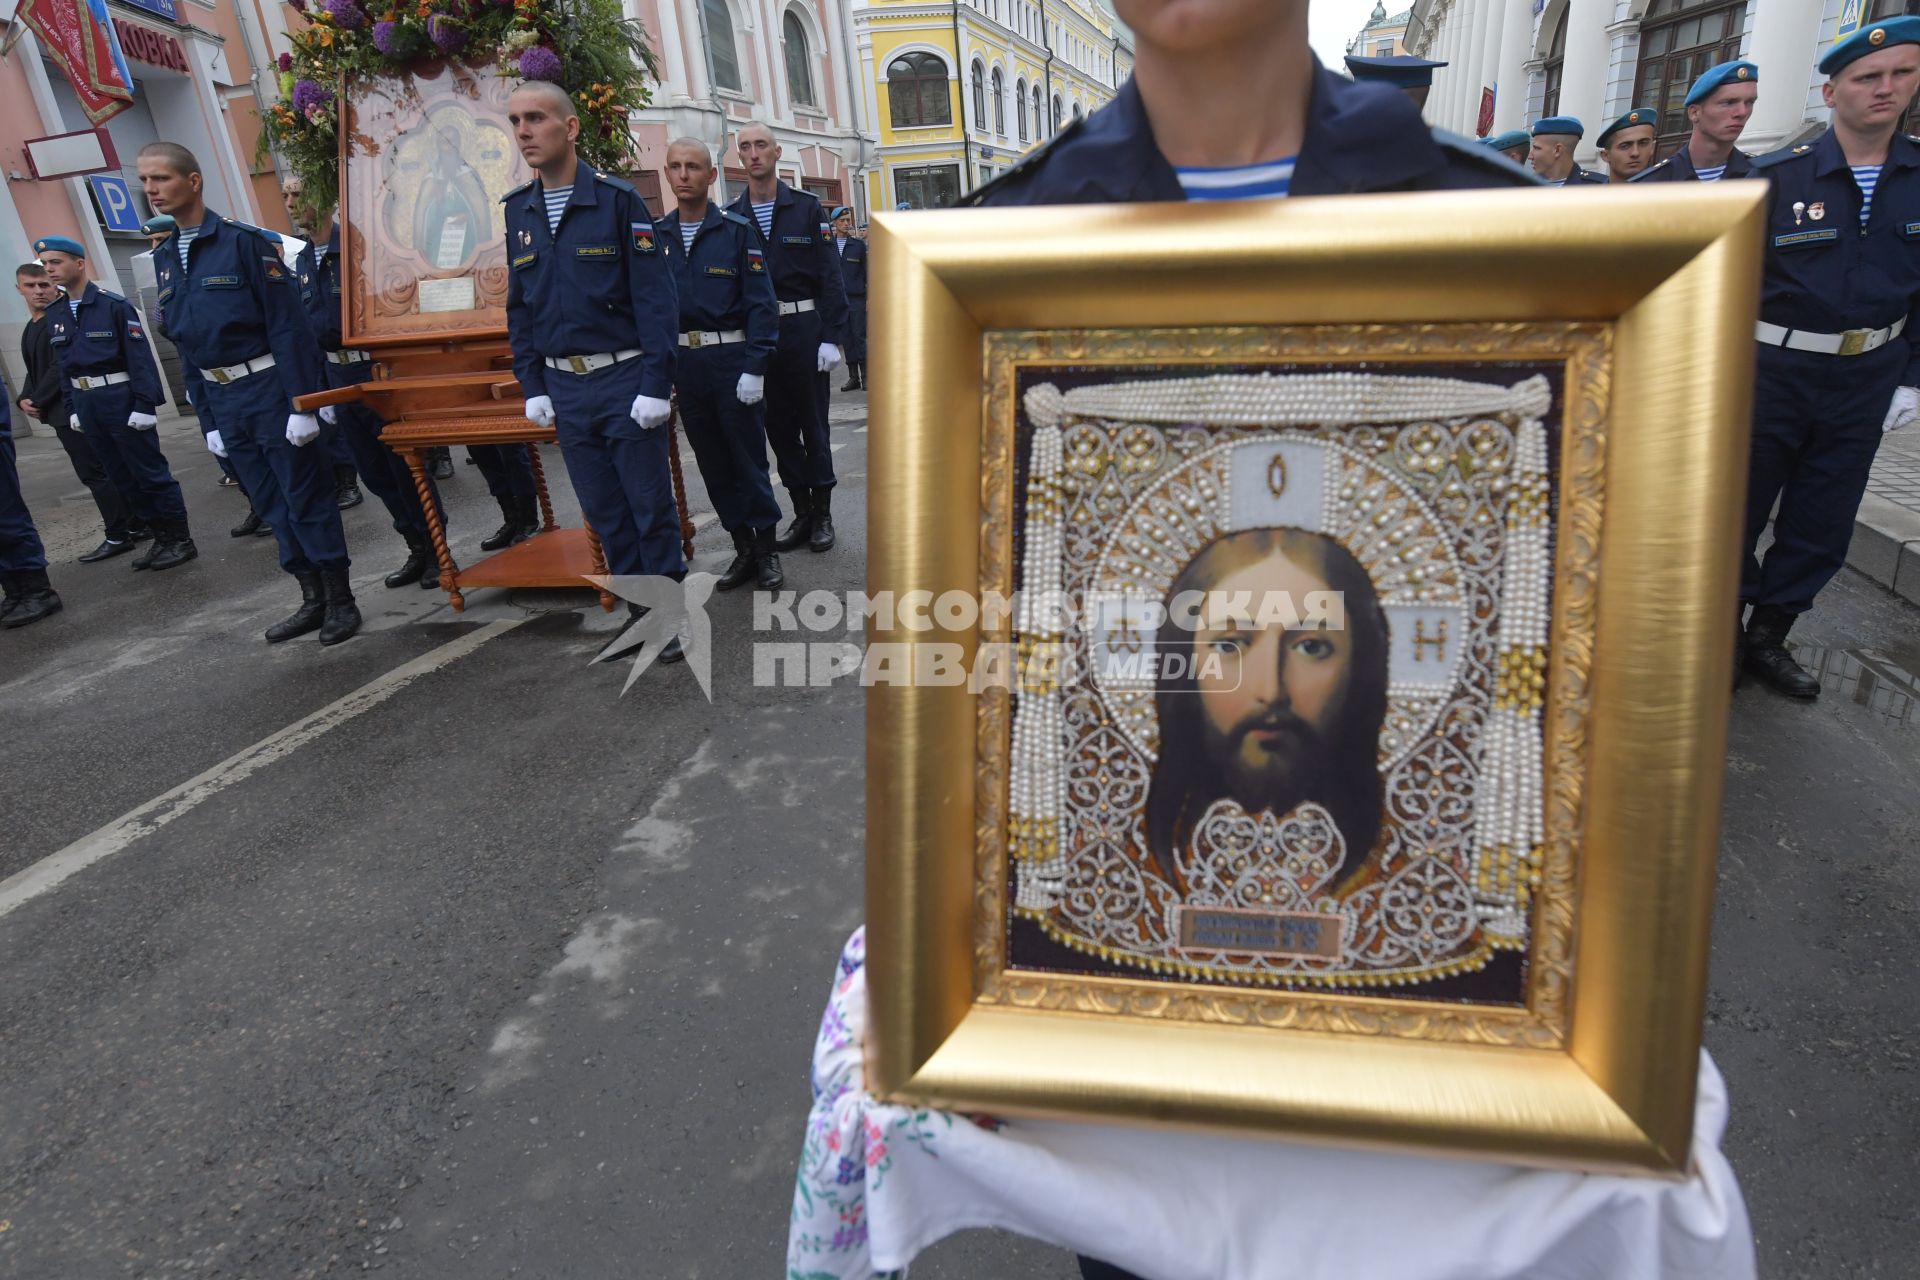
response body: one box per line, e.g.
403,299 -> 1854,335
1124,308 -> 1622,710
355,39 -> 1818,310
205,372 -> 348,574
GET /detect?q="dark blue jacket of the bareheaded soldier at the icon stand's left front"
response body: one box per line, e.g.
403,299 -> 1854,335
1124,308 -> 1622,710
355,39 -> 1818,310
154,209 -> 326,411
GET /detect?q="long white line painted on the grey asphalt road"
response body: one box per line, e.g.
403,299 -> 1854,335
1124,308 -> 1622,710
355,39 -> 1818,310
0,618 -> 526,915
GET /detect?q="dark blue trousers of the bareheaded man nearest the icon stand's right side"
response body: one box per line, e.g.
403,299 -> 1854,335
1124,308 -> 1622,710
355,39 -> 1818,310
547,361 -> 687,576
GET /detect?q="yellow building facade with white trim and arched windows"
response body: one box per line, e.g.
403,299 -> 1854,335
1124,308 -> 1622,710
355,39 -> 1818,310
852,0 -> 1133,209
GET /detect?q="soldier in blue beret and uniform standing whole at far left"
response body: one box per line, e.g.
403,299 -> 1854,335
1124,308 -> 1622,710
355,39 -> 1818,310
33,236 -> 200,570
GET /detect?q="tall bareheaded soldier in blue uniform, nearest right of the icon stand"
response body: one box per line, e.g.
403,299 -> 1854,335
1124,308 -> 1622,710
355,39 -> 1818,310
501,81 -> 687,662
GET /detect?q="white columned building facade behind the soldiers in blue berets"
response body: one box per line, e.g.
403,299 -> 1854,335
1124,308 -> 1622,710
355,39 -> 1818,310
1405,0 -> 1896,163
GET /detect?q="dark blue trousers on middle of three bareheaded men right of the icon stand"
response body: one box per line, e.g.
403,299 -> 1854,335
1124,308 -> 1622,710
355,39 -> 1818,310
674,342 -> 780,533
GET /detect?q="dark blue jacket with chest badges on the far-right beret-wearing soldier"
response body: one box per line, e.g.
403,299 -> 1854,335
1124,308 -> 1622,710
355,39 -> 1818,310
1753,129 -> 1920,386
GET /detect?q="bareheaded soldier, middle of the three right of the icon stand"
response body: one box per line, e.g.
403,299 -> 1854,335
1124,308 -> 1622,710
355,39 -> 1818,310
659,138 -> 785,591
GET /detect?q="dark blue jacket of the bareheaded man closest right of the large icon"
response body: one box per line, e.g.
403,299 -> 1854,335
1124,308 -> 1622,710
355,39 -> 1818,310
501,161 -> 680,399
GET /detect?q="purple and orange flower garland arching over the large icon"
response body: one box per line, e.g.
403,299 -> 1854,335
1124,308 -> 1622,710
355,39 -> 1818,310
261,0 -> 659,207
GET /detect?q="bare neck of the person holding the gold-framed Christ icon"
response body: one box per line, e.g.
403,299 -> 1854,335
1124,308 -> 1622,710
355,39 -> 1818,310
1133,24 -> 1313,169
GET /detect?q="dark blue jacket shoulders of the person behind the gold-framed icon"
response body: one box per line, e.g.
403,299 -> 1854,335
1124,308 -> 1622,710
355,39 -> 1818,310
960,59 -> 1538,205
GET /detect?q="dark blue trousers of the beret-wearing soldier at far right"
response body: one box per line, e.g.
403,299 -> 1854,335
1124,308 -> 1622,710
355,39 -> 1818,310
1740,342 -> 1908,614
